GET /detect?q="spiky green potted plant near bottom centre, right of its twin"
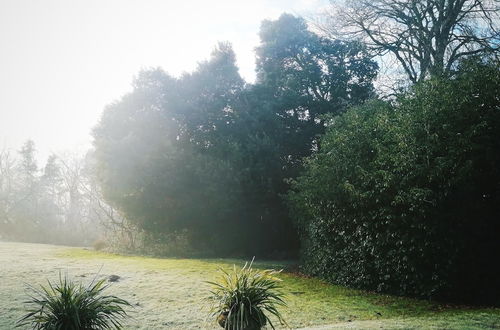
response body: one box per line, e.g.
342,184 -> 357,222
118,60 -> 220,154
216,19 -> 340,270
208,260 -> 286,330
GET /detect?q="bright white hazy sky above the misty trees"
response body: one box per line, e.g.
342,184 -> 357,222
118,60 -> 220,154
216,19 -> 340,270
0,0 -> 328,165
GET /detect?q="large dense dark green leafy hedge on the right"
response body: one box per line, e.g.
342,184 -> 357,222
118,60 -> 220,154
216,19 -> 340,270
288,64 -> 500,303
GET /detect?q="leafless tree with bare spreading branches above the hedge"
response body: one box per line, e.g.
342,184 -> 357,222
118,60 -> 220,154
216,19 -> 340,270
326,0 -> 500,83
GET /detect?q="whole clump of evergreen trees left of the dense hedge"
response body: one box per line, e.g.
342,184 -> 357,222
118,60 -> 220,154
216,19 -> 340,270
94,15 -> 376,257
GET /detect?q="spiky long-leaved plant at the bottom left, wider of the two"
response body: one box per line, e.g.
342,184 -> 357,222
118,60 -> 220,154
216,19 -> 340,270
17,275 -> 131,330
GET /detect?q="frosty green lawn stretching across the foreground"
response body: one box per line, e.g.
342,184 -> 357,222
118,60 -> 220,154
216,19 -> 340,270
0,242 -> 500,329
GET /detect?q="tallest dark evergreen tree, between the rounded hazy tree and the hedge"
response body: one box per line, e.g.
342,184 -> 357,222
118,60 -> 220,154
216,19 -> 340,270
231,14 -> 377,255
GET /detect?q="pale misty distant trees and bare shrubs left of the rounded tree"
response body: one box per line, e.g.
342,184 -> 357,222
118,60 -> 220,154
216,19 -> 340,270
0,140 -> 135,246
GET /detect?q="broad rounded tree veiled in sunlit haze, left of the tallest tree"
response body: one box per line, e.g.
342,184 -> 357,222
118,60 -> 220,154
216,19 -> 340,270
94,44 -> 260,254
